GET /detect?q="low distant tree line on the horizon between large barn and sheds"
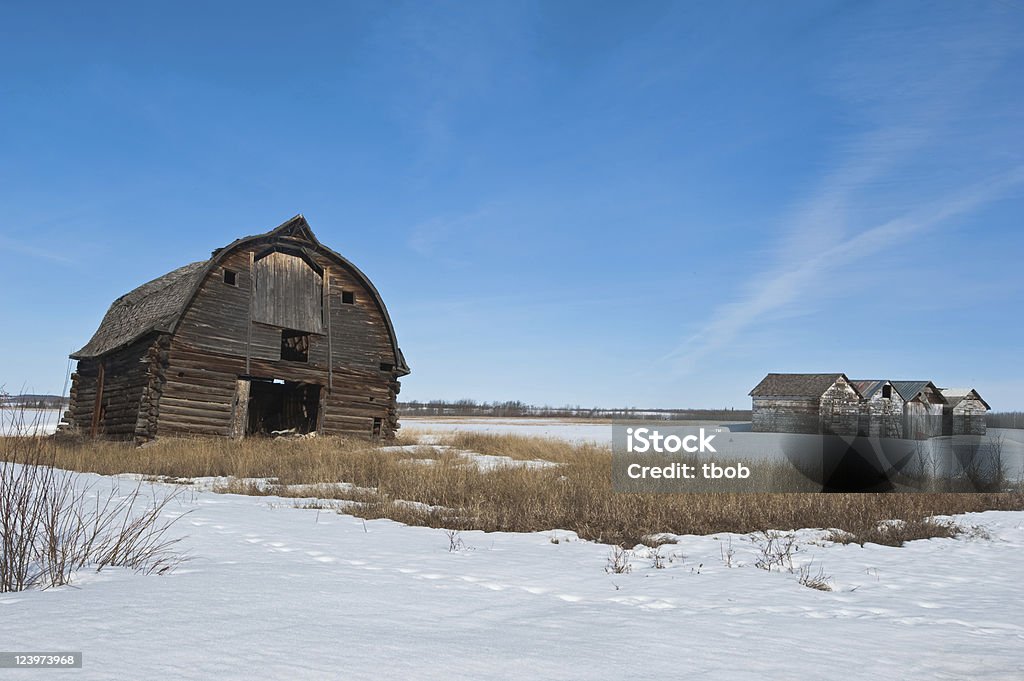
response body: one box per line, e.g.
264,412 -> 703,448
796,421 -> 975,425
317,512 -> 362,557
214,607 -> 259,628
398,399 -> 751,421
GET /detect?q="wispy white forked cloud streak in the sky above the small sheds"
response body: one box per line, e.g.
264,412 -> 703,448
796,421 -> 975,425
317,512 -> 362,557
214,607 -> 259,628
663,9 -> 1024,374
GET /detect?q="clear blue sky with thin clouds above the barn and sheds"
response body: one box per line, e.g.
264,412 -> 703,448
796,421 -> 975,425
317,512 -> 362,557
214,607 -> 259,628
0,0 -> 1024,410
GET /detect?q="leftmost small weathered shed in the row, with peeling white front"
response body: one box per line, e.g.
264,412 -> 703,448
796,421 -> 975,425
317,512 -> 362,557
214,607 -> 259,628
750,374 -> 861,435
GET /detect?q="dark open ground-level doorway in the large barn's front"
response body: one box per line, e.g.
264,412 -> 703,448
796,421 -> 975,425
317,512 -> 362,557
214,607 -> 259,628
246,379 -> 321,435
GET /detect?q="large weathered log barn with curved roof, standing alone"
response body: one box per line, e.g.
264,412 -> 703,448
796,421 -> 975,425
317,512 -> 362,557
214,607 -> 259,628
61,215 -> 409,441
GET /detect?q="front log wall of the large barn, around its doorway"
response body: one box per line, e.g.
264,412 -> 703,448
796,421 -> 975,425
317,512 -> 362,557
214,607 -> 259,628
158,241 -> 398,436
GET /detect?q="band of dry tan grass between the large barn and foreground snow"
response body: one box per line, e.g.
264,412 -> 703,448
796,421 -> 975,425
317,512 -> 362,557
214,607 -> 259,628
4,433 -> 1024,546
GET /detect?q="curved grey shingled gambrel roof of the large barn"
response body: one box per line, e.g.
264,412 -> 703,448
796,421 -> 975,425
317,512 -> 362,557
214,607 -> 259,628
71,214 -> 409,375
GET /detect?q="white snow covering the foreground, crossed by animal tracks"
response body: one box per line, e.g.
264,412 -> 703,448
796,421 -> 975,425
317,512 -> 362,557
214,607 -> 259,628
0,475 -> 1024,681
